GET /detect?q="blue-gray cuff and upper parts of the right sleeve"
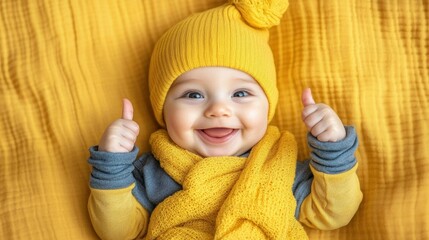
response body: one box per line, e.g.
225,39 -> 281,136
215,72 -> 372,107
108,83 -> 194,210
292,126 -> 358,219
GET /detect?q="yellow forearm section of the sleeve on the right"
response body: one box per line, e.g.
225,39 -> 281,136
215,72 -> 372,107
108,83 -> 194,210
299,164 -> 363,230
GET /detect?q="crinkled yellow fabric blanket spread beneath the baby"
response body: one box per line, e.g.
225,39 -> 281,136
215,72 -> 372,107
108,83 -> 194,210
0,0 -> 429,240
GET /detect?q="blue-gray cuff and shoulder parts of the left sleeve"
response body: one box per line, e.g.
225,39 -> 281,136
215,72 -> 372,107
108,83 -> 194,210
88,146 -> 181,212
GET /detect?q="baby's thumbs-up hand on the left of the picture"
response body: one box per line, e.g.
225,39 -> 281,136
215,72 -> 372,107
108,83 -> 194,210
98,99 -> 139,152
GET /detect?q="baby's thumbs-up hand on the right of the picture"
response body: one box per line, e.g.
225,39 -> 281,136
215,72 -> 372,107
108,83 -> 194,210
302,88 -> 346,142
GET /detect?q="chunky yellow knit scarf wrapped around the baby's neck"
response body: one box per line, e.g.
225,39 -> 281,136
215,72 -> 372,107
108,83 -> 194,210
146,126 -> 307,240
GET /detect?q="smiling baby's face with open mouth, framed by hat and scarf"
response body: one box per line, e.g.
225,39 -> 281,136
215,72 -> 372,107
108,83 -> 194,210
163,67 -> 268,157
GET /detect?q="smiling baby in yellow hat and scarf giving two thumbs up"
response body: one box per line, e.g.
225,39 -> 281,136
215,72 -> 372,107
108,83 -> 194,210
88,1 -> 362,239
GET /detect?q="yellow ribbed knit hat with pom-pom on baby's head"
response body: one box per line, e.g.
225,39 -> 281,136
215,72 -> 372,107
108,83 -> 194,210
149,0 -> 288,126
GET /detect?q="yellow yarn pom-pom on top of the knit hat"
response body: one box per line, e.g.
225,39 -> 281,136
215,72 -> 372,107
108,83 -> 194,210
230,0 -> 289,28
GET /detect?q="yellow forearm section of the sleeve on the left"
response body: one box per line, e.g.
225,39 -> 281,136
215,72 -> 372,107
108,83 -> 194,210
88,183 -> 149,239
